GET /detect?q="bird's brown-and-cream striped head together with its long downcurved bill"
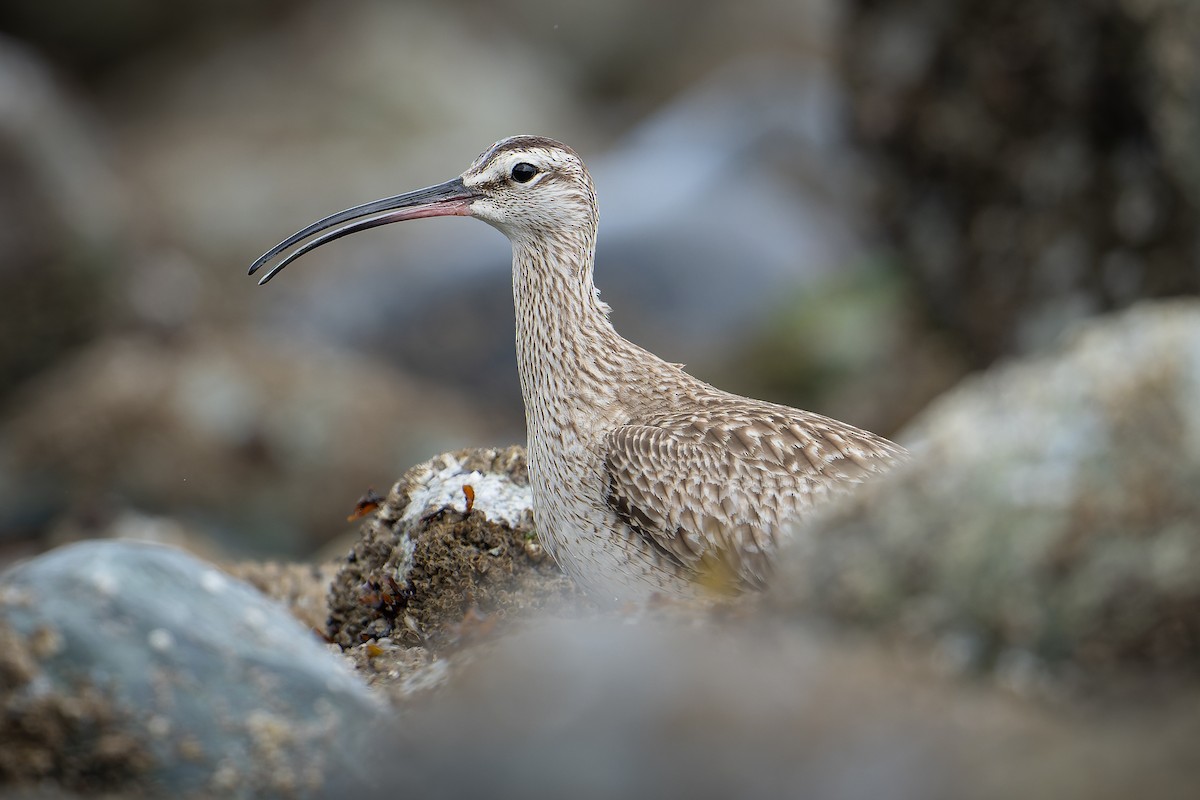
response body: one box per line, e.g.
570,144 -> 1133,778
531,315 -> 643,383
250,136 -> 596,283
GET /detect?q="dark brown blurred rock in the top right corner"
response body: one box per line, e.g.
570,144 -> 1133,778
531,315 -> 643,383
842,0 -> 1200,368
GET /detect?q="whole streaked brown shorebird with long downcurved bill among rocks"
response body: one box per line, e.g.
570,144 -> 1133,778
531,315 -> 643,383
250,136 -> 907,603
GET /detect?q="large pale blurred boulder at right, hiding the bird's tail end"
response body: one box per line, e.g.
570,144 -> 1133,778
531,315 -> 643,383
773,301 -> 1200,685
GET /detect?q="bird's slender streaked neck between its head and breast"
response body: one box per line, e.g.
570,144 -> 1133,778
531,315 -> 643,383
512,231 -> 630,437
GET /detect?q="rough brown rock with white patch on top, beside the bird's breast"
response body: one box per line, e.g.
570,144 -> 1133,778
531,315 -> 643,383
329,447 -> 581,662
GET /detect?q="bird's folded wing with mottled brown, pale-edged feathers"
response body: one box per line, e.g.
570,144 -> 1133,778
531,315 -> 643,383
604,401 -> 905,588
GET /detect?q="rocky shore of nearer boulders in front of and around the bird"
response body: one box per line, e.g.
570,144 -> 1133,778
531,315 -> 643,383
0,302 -> 1200,798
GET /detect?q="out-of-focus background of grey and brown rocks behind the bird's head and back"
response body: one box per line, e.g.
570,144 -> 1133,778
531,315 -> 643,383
0,0 -> 1200,563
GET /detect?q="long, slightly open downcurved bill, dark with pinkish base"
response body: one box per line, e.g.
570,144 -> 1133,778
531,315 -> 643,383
250,178 -> 479,285
